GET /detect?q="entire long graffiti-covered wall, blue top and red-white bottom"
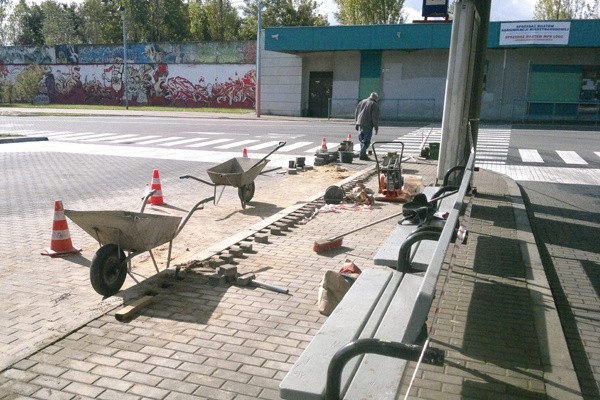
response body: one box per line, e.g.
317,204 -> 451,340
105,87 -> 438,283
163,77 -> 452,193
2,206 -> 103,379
0,42 -> 256,108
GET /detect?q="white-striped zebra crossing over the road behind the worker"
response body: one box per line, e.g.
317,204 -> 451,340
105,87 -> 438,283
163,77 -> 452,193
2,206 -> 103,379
3,124 -> 600,168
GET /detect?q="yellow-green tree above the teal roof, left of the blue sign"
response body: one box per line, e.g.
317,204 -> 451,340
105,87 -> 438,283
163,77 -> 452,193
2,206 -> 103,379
334,0 -> 406,25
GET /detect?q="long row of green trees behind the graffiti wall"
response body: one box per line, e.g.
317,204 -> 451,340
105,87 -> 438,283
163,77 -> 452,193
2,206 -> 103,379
0,0 -> 330,45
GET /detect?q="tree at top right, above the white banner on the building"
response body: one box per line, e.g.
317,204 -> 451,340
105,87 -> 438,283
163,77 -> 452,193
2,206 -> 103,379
533,0 -> 600,20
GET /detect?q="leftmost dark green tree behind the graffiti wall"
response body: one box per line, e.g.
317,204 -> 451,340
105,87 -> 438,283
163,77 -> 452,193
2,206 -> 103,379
6,0 -> 44,46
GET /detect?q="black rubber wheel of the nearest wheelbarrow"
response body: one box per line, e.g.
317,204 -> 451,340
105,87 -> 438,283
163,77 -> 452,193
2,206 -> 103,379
90,244 -> 127,296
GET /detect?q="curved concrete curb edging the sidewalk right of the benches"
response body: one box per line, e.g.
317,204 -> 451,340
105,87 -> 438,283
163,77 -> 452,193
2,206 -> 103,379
502,171 -> 583,400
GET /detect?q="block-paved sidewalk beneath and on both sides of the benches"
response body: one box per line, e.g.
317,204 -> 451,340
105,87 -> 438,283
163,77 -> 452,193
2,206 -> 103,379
0,137 -> 581,399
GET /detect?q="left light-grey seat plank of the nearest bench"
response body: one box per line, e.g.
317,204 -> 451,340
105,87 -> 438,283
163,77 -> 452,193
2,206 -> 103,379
279,268 -> 393,400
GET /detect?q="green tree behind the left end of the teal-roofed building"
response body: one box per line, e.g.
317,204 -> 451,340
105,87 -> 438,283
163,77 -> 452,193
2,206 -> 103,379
240,0 -> 328,39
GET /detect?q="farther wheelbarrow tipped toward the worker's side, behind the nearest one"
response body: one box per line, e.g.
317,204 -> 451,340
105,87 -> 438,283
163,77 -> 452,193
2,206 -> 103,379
180,142 -> 286,209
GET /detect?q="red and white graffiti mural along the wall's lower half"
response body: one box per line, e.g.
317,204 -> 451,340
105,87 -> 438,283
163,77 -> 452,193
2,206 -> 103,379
0,63 -> 256,108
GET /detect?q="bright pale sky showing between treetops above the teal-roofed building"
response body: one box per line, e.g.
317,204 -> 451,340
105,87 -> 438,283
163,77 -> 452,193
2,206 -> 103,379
317,0 -> 536,25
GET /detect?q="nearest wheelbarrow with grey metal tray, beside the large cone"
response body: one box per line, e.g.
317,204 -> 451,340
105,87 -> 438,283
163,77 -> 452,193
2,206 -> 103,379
65,190 -> 213,296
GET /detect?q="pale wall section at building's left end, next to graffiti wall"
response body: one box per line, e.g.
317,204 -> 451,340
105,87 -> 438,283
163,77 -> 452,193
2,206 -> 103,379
260,50 -> 303,116
